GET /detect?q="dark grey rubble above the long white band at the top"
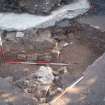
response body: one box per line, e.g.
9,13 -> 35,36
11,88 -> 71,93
0,0 -> 73,14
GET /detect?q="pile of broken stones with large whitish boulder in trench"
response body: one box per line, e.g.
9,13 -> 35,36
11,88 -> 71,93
15,66 -> 68,104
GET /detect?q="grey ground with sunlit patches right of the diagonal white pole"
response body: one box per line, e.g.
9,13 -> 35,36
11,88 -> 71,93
51,50 -> 105,105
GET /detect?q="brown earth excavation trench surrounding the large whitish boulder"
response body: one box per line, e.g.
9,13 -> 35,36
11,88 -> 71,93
0,22 -> 105,105
